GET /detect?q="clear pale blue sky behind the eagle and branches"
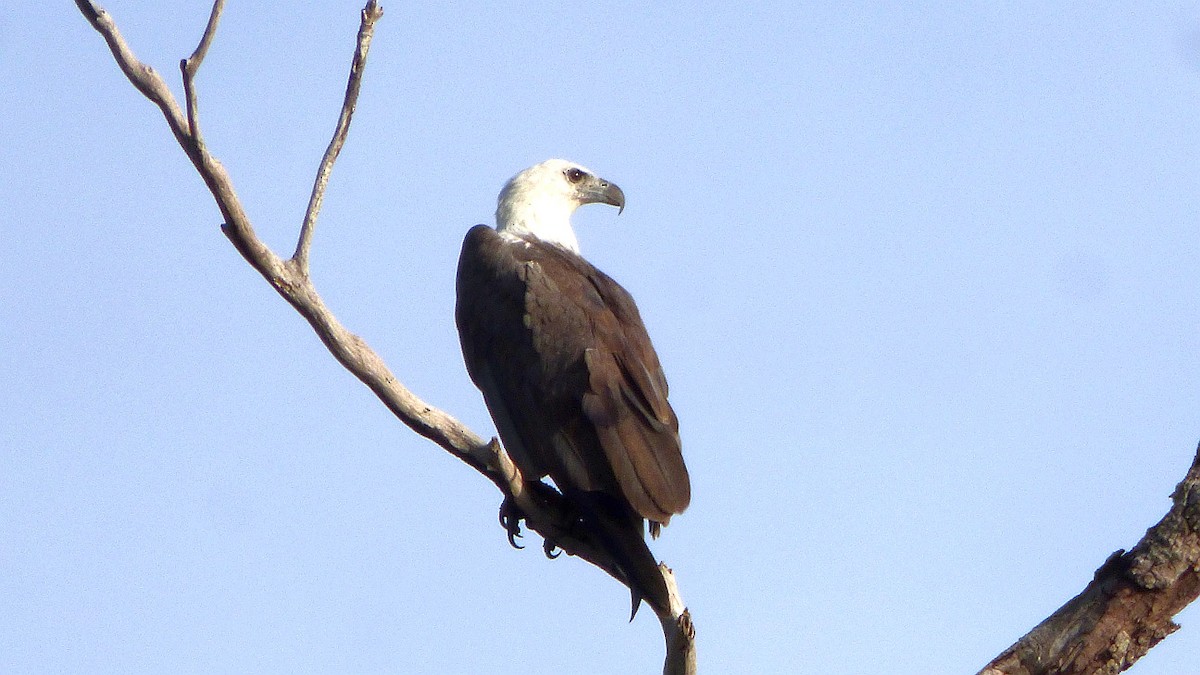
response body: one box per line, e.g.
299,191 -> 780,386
0,0 -> 1200,675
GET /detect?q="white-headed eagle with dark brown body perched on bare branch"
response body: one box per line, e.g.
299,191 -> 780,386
455,160 -> 691,619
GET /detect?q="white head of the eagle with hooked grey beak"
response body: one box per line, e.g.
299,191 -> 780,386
496,160 -> 625,253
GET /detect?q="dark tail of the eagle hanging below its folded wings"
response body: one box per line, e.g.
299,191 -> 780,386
576,485 -> 671,621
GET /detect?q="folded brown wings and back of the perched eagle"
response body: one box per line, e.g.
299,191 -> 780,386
456,226 -> 691,522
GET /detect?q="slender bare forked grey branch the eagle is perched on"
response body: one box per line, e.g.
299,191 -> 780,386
76,0 -> 696,675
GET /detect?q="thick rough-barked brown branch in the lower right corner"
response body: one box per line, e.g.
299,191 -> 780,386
979,448 -> 1200,675
